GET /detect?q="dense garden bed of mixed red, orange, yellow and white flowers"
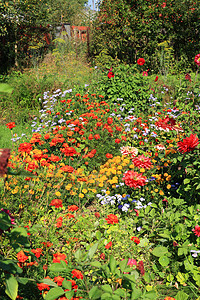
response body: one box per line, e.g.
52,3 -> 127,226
0,54 -> 200,300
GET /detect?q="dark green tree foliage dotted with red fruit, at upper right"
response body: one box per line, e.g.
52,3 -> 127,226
91,0 -> 200,71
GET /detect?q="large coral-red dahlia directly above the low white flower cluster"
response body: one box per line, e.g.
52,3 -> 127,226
122,170 -> 147,188
